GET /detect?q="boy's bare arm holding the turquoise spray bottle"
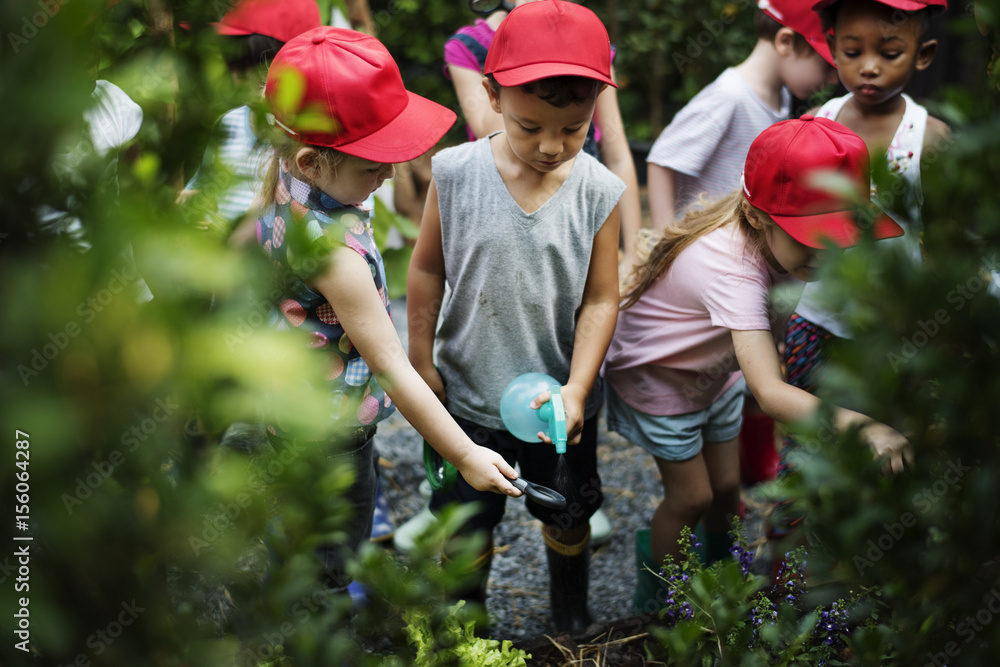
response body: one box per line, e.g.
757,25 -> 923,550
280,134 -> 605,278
531,206 -> 619,445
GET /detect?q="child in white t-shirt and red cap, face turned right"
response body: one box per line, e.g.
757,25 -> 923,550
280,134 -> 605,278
647,0 -> 836,484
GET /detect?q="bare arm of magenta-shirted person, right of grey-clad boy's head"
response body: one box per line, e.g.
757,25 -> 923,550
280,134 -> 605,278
594,86 -> 642,270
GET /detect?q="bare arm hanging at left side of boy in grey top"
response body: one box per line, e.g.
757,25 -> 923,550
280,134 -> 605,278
406,177 -> 447,403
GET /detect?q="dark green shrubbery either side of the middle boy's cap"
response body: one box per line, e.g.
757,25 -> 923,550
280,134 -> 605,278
371,0 -> 755,141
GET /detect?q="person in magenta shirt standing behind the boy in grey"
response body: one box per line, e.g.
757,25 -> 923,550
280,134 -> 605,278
444,0 -> 642,272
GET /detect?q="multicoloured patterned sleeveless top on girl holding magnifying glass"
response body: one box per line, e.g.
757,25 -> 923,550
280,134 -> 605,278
257,161 -> 396,435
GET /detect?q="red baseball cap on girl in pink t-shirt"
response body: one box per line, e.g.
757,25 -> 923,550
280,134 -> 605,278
743,114 -> 903,248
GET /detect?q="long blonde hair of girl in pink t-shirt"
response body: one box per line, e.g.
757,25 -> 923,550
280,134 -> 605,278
621,190 -> 773,309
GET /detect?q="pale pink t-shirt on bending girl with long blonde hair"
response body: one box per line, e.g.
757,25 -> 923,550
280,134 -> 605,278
604,225 -> 798,416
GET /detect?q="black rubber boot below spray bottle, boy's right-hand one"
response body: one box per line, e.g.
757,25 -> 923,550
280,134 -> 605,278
542,528 -> 594,636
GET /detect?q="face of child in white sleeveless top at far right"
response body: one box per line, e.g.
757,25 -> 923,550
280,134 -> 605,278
829,0 -> 936,107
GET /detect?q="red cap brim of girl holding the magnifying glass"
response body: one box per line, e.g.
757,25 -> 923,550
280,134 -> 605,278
320,91 -> 458,163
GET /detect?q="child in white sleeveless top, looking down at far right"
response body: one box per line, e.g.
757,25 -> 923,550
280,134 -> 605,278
768,0 -> 949,552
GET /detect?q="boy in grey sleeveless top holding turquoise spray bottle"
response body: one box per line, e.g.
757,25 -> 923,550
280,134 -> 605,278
407,0 -> 625,632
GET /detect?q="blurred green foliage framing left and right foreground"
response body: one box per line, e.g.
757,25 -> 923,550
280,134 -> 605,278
0,0 -> 1000,667
